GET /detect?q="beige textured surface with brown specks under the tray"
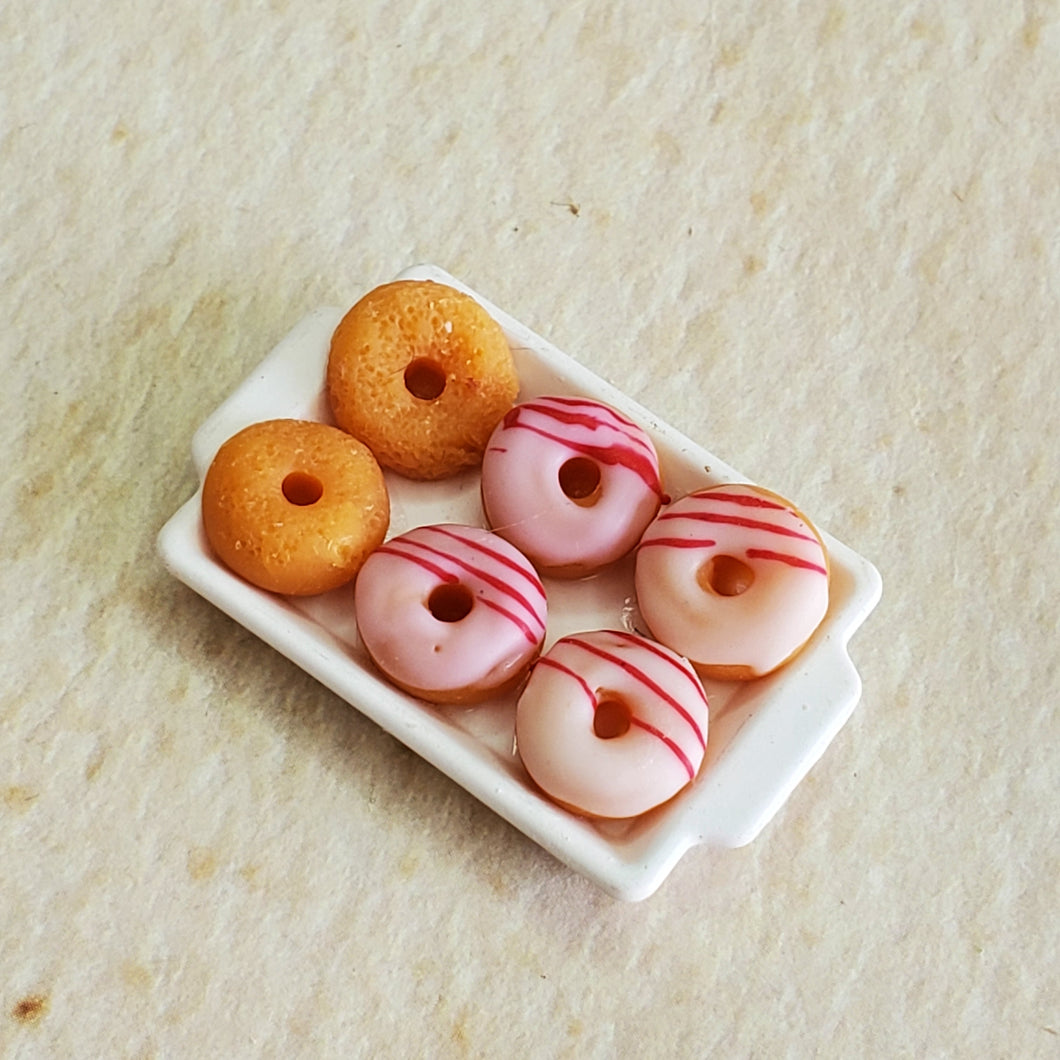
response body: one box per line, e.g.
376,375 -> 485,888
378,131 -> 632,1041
0,0 -> 1060,1058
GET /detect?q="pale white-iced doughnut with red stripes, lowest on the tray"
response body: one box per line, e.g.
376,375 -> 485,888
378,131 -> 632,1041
515,630 -> 708,817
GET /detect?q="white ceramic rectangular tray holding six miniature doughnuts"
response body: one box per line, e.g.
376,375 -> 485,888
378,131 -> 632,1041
158,265 -> 881,901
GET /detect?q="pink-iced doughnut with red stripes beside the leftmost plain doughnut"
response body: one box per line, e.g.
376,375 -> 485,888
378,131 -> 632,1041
354,524 -> 547,703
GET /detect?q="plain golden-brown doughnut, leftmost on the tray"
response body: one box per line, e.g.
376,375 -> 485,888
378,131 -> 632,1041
202,420 -> 390,596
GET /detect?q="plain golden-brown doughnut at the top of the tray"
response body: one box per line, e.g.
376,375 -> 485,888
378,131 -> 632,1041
326,280 -> 518,480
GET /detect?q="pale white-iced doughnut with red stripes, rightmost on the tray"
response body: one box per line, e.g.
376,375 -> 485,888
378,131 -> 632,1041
635,483 -> 829,681
